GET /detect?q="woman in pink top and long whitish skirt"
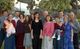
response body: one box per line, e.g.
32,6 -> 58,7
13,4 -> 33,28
42,15 -> 54,49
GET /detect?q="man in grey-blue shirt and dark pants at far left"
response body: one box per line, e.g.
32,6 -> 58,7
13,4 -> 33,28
0,11 -> 8,48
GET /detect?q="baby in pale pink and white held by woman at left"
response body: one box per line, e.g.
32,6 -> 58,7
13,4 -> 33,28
4,20 -> 16,37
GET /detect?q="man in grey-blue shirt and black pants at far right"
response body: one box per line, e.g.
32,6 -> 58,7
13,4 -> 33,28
69,12 -> 80,49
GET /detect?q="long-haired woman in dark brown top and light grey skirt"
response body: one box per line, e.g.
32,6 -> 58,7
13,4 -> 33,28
24,16 -> 32,49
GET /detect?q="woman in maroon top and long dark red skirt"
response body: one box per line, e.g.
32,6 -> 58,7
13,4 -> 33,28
16,14 -> 25,49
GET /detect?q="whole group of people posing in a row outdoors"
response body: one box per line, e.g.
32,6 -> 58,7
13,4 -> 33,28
0,11 -> 80,49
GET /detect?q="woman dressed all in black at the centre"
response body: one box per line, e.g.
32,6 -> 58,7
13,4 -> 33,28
31,12 -> 43,49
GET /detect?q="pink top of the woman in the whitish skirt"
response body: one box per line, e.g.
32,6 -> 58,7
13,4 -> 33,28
43,22 -> 54,37
